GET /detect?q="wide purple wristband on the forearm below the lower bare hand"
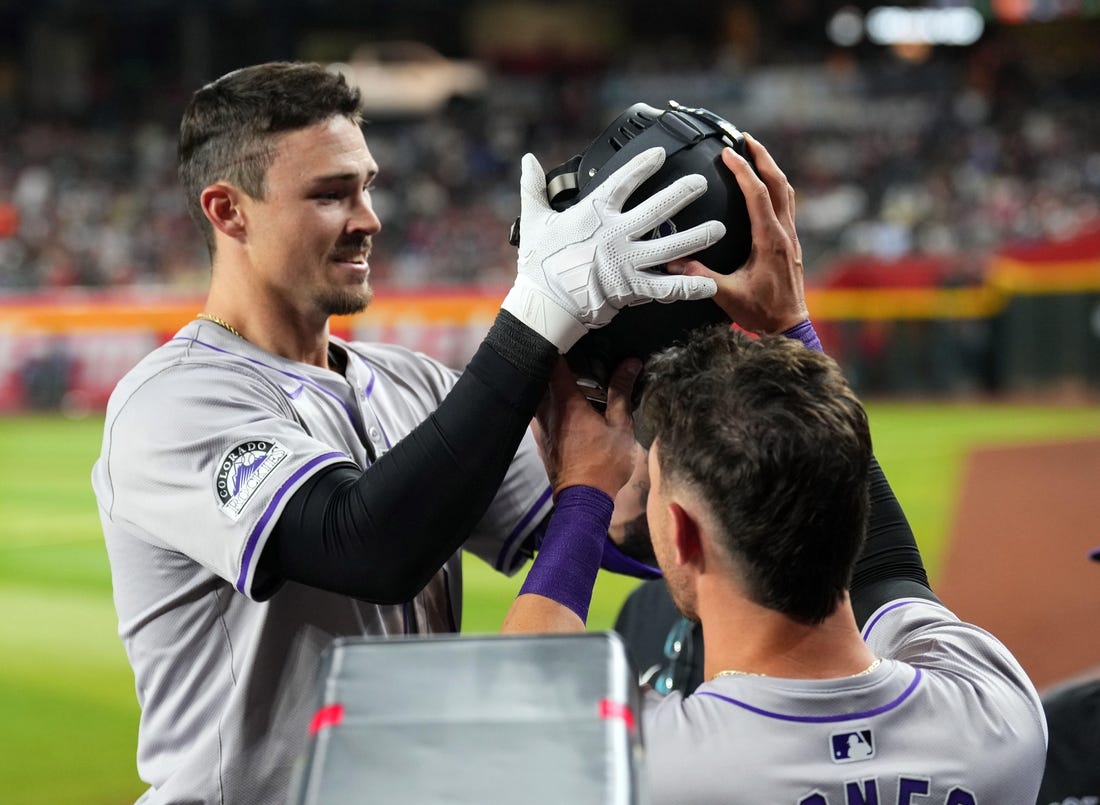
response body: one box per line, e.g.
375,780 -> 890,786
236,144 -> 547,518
519,486 -> 615,621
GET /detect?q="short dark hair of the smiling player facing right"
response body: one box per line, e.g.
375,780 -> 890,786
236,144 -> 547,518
178,62 -> 361,254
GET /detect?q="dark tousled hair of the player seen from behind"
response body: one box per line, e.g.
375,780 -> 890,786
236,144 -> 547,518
635,326 -> 871,624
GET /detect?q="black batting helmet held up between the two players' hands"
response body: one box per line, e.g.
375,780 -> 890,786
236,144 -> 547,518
532,101 -> 752,406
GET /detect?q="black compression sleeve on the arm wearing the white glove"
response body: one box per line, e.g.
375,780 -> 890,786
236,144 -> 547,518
256,311 -> 558,604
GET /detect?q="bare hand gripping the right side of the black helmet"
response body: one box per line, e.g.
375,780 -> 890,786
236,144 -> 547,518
669,134 -> 809,333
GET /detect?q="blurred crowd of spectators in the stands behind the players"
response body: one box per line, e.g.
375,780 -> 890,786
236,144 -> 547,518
0,47 -> 1100,291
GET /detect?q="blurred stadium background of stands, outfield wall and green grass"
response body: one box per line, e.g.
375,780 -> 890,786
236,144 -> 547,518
0,0 -> 1100,803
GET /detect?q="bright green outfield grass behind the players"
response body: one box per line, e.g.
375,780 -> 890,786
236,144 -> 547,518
0,404 -> 1100,805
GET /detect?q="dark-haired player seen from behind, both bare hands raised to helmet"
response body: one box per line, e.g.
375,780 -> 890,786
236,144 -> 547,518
504,140 -> 1046,805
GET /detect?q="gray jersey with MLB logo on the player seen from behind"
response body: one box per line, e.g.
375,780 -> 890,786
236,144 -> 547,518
642,598 -> 1046,805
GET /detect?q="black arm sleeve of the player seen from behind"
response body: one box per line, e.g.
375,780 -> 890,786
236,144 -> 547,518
850,459 -> 938,628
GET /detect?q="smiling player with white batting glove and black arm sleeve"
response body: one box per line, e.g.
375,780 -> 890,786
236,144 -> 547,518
92,63 -> 723,805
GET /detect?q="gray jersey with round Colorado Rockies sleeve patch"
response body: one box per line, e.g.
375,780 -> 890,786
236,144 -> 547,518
92,321 -> 551,803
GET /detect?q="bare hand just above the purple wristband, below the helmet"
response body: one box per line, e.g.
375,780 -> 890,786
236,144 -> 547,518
534,359 -> 641,497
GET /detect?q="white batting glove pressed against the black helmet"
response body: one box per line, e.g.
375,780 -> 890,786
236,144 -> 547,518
501,147 -> 726,353
